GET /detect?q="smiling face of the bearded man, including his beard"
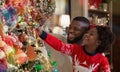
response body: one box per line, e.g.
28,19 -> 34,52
67,20 -> 84,43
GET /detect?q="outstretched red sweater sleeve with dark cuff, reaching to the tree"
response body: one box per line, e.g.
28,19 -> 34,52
40,31 -> 74,55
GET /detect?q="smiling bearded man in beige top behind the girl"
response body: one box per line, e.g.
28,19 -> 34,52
44,16 -> 90,72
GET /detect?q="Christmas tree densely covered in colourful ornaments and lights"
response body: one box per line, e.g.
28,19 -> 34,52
0,0 -> 58,72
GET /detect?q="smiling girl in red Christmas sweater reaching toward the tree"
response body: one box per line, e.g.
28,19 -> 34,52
38,26 -> 114,72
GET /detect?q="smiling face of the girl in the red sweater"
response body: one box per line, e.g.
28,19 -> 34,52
83,28 -> 99,46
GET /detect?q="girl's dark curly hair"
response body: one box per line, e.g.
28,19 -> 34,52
95,26 -> 114,53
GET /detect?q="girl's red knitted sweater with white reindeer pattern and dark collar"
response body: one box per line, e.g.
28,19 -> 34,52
41,32 -> 110,72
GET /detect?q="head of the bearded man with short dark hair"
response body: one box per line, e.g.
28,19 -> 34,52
67,16 -> 90,44
